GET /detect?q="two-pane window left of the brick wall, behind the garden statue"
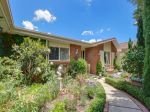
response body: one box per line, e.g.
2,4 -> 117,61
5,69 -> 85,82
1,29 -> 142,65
49,47 -> 69,61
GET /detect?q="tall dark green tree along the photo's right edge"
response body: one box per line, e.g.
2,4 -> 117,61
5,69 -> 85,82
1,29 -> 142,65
143,0 -> 150,96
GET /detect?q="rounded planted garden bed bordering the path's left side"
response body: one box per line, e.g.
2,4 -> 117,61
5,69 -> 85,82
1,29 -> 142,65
42,76 -> 106,112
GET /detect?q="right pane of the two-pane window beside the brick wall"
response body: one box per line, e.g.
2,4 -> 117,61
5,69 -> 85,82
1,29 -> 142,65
60,48 -> 69,60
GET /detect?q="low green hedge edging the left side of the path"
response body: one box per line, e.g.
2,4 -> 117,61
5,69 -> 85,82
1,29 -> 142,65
86,83 -> 106,112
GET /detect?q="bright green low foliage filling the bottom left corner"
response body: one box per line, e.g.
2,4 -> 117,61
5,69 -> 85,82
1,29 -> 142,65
0,77 -> 59,112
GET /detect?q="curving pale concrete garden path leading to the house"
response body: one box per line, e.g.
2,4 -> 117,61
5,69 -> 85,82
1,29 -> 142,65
98,78 -> 148,112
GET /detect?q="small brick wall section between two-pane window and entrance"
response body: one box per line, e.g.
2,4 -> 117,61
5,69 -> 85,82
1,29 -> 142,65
70,44 -> 81,59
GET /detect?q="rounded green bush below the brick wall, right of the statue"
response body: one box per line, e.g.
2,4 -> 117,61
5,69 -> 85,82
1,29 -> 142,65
68,59 -> 87,78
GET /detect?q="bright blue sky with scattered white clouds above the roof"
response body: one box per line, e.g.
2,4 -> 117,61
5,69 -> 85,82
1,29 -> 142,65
10,0 -> 137,43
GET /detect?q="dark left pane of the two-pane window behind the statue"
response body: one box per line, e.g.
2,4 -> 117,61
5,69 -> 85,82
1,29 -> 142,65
49,47 -> 59,60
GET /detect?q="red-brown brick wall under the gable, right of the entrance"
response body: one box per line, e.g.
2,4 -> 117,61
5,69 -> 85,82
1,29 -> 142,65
85,45 -> 103,74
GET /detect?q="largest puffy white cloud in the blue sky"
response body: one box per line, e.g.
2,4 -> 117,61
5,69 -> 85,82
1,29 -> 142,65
33,9 -> 56,23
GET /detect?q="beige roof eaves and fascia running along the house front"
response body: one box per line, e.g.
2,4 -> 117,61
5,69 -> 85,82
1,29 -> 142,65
0,0 -> 120,49
